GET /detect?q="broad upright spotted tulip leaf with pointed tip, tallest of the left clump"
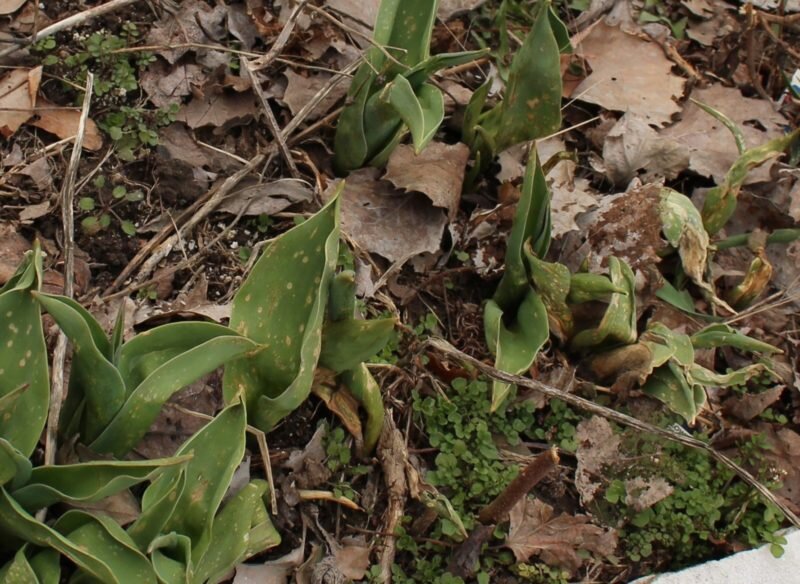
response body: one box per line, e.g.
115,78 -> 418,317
223,187 -> 341,431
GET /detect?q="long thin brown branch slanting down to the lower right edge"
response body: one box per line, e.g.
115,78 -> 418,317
423,338 -> 800,527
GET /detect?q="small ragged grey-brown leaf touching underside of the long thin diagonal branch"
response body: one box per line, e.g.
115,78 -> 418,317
575,416 -> 620,505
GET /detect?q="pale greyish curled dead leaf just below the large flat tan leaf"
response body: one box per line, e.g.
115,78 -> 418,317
603,112 -> 689,186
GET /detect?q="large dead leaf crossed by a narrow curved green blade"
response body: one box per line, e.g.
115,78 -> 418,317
659,85 -> 787,183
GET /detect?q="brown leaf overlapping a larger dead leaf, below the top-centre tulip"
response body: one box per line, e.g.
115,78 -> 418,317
383,142 -> 469,221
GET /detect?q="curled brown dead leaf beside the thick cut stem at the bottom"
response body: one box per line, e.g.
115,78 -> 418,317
505,497 -> 617,572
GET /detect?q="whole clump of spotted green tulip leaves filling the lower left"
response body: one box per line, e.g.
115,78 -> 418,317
0,193 -> 395,584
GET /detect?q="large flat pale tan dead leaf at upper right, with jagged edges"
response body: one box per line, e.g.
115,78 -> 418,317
573,22 -> 686,126
